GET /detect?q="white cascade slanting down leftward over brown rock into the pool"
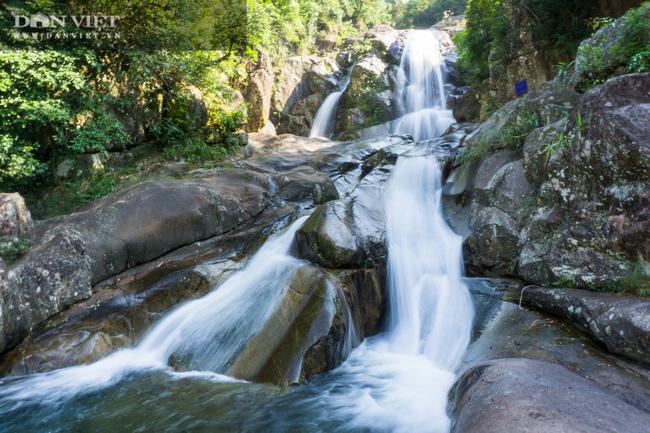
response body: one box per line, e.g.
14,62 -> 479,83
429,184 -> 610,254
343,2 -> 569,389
0,216 -> 307,401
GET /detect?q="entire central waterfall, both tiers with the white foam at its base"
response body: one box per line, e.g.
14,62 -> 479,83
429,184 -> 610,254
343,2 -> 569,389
322,31 -> 474,433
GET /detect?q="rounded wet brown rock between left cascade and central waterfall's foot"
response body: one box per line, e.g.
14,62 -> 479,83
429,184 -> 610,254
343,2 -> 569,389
227,265 -> 353,383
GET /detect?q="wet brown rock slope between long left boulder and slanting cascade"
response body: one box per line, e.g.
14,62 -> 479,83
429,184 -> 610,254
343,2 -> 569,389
0,271 -> 210,375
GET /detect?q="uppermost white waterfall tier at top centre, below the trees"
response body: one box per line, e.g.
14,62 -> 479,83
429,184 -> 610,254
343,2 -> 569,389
392,30 -> 454,141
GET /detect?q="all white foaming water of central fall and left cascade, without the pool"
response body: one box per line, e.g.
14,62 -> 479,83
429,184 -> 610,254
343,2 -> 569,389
0,32 -> 473,433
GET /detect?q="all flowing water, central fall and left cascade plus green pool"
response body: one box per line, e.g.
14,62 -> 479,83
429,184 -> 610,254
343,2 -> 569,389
0,28 -> 473,433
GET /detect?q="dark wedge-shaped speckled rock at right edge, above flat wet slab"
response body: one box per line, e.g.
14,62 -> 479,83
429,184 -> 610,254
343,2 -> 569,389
522,287 -> 650,364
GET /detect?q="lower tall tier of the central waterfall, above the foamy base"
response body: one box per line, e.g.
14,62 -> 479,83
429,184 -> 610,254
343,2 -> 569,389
386,156 -> 473,371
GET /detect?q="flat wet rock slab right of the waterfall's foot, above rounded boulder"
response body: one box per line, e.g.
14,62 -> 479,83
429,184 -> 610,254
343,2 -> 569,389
461,284 -> 650,412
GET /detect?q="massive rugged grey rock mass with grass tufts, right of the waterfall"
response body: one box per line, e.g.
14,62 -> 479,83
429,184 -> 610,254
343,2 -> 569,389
447,73 -> 650,290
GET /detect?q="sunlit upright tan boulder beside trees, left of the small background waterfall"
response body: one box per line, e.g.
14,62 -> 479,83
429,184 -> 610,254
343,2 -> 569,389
245,51 -> 275,131
